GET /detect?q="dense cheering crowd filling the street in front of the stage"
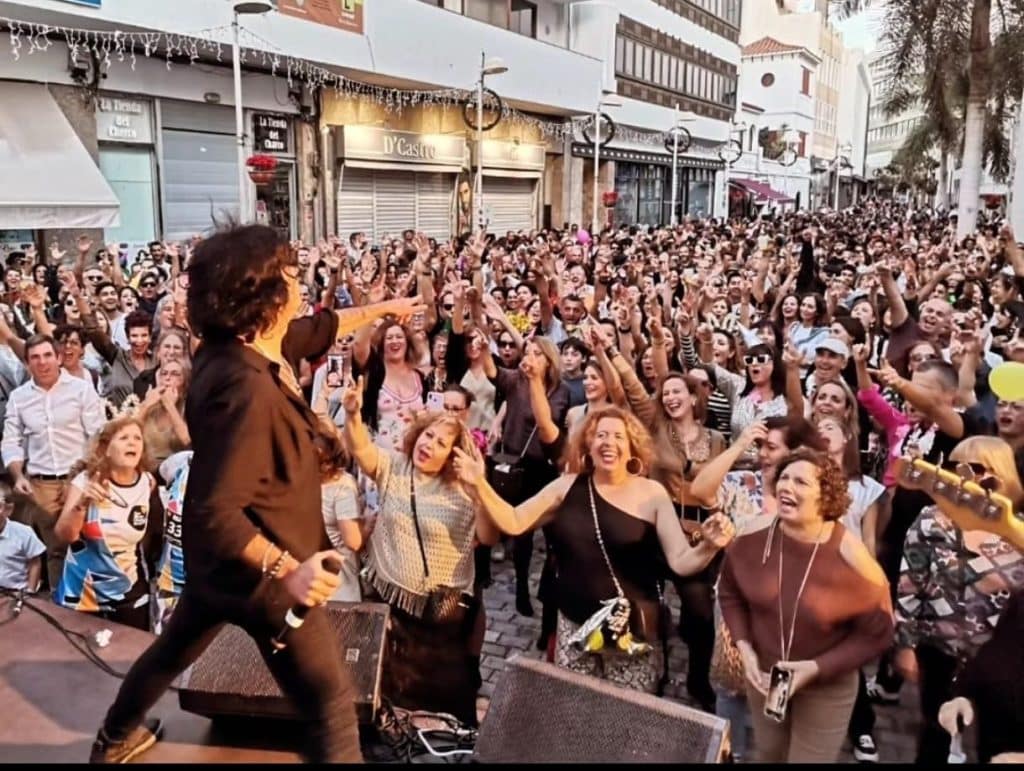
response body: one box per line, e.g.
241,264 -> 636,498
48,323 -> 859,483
0,202 -> 1024,763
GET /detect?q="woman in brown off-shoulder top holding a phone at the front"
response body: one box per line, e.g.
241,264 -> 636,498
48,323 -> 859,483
719,449 -> 893,763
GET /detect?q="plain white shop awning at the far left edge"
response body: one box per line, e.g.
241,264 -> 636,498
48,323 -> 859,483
0,82 -> 120,230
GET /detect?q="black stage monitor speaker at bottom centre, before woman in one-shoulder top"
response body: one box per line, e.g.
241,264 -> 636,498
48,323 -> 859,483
473,656 -> 729,763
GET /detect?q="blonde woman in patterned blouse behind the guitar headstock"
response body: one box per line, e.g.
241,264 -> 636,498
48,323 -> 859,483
895,436 -> 1024,764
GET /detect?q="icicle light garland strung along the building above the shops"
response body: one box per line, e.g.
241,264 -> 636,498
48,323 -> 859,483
0,16 -> 696,146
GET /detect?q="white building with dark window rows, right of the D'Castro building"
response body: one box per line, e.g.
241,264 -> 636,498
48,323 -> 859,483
569,0 -> 742,224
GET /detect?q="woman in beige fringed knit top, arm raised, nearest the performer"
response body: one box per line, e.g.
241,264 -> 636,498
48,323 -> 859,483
342,376 -> 498,725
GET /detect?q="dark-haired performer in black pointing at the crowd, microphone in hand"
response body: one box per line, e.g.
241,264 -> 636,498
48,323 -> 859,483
91,225 -> 422,763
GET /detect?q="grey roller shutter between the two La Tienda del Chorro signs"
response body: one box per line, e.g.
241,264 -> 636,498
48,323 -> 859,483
163,130 -> 239,241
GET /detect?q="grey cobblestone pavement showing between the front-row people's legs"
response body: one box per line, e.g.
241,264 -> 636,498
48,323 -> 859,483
477,538 -> 929,763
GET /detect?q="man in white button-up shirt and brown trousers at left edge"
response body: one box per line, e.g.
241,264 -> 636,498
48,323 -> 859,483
0,335 -> 105,589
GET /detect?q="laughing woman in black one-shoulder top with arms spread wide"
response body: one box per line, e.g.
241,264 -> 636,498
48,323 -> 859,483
456,406 -> 733,692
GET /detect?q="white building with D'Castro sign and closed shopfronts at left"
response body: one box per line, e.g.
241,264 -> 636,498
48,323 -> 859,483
0,0 -> 613,250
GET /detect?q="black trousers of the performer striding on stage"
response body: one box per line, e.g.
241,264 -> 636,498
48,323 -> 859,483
103,581 -> 362,762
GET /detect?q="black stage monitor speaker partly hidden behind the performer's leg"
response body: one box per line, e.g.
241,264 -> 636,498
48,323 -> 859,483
178,602 -> 390,724
